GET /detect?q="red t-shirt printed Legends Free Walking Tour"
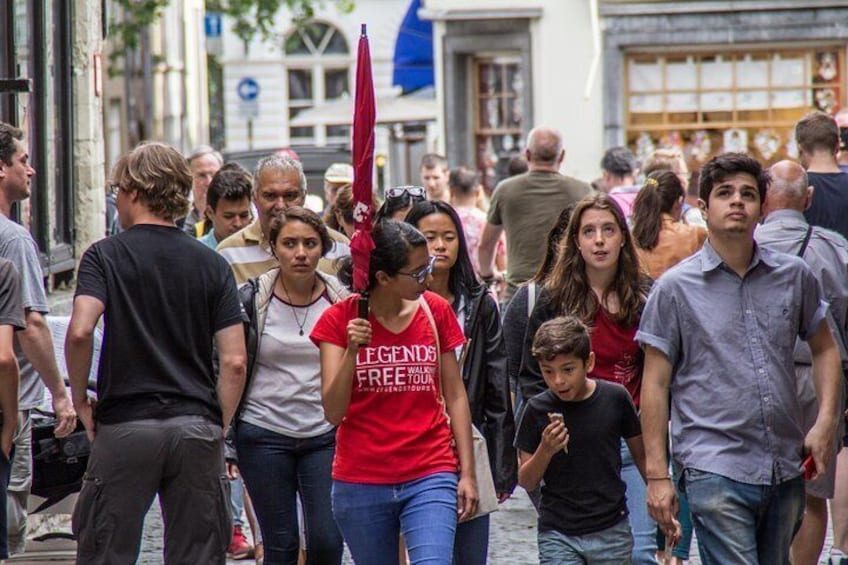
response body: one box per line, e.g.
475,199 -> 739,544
310,292 -> 465,484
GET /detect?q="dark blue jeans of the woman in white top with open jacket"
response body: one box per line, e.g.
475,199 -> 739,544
236,422 -> 344,565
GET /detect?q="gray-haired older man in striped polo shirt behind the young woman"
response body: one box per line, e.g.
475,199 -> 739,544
217,155 -> 350,284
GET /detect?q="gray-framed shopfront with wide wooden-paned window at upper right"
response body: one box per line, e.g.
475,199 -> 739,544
600,0 -> 848,173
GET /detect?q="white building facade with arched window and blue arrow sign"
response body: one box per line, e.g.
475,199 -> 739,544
220,0 -> 436,192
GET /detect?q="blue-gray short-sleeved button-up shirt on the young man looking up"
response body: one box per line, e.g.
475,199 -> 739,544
636,242 -> 827,485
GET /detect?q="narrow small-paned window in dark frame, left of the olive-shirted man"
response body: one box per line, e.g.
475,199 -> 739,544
473,56 -> 524,191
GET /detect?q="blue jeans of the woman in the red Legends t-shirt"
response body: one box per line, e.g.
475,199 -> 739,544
333,473 -> 458,565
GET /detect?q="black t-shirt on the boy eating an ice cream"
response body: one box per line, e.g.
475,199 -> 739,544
515,380 -> 642,536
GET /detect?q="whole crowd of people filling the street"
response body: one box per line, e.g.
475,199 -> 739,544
0,108 -> 848,565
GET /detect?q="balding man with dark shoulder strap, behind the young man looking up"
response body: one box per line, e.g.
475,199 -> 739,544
754,161 -> 848,563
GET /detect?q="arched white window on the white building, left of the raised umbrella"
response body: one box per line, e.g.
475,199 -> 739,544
285,22 -> 351,145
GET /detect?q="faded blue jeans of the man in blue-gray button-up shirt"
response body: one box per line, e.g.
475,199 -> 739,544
683,469 -> 804,565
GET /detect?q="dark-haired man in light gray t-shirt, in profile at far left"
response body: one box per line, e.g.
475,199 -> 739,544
0,122 -> 76,553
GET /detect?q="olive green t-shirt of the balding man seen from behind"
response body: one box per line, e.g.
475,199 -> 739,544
488,171 -> 592,294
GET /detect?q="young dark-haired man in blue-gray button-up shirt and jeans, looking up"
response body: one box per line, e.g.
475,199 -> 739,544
636,153 -> 842,565
